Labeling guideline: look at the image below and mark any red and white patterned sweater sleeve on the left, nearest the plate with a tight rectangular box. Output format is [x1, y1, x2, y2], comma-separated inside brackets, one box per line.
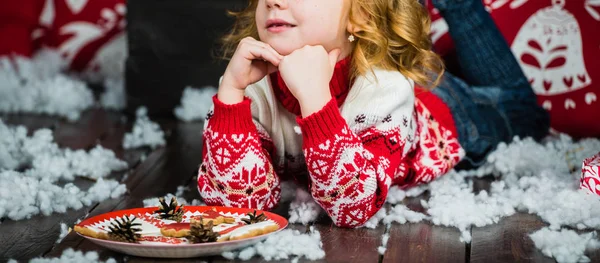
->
[198, 96, 281, 210]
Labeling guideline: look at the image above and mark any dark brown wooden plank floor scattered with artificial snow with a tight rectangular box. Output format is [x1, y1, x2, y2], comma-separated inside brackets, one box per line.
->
[0, 110, 600, 263]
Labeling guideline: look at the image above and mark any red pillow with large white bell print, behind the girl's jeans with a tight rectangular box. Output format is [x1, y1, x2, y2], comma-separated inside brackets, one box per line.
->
[427, 0, 600, 137]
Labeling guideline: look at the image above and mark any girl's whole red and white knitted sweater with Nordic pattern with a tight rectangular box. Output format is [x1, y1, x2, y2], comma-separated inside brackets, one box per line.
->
[198, 59, 464, 227]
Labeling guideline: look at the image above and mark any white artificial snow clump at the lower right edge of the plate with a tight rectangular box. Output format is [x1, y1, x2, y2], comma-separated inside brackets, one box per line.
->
[222, 227, 325, 261]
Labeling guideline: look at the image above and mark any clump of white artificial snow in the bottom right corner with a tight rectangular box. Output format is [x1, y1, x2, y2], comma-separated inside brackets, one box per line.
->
[530, 227, 600, 263]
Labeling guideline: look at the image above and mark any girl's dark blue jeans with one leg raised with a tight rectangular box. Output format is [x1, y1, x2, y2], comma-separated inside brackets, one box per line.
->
[432, 0, 550, 168]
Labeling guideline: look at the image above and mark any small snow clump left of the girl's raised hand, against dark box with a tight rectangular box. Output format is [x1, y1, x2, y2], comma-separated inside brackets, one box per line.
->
[175, 87, 217, 122]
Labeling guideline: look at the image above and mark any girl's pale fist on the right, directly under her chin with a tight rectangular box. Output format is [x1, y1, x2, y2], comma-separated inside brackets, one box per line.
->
[279, 46, 341, 117]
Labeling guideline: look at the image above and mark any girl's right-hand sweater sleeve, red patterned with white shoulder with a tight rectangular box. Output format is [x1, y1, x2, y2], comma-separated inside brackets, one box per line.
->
[298, 72, 416, 227]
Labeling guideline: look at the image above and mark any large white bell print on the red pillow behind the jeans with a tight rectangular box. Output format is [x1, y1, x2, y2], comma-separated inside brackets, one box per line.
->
[511, 0, 592, 99]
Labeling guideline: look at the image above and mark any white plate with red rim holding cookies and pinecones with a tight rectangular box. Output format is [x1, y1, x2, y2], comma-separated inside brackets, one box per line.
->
[76, 206, 288, 258]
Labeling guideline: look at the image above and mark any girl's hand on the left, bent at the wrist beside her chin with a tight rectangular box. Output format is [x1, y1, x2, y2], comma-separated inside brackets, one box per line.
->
[217, 37, 283, 104]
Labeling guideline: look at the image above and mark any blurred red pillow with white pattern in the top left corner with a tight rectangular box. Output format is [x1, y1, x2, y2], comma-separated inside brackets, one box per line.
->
[0, 0, 126, 78]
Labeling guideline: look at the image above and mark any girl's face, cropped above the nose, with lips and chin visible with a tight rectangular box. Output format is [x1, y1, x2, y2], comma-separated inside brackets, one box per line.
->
[256, 0, 352, 59]
